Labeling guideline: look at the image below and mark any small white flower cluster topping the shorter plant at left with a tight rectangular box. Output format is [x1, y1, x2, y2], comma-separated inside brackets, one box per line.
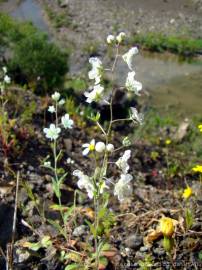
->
[43, 92, 74, 141]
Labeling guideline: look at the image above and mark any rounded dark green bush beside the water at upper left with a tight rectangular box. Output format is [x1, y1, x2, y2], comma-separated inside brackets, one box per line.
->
[0, 13, 68, 94]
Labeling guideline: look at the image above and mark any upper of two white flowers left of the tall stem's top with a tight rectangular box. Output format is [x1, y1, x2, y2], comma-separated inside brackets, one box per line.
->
[88, 57, 103, 84]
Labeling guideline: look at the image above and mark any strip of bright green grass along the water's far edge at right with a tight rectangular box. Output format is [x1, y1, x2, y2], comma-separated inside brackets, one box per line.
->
[131, 33, 202, 56]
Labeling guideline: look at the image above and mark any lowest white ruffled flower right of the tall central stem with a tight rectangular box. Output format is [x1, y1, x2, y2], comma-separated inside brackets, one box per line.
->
[114, 174, 133, 201]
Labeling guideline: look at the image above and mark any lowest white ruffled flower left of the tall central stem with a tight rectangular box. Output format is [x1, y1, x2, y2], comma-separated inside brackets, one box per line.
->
[73, 170, 94, 199]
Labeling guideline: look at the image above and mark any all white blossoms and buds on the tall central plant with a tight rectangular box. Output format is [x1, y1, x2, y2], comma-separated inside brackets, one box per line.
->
[72, 32, 143, 201]
